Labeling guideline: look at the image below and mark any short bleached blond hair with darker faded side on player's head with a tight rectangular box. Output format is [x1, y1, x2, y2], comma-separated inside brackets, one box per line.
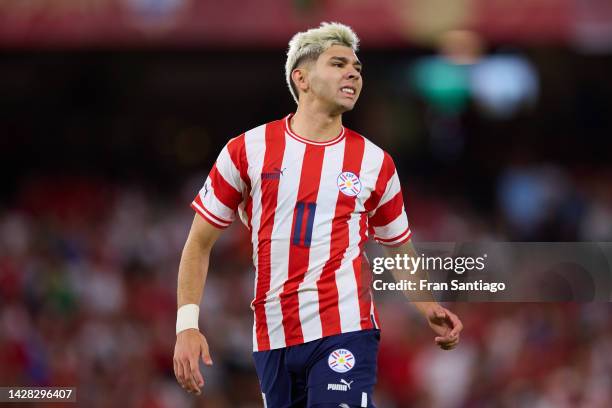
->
[285, 23, 359, 103]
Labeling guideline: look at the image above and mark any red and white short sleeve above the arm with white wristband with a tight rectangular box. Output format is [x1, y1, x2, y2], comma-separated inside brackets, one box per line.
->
[191, 138, 246, 228]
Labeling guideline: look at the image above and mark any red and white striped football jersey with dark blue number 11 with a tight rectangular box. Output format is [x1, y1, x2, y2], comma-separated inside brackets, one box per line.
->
[191, 115, 411, 351]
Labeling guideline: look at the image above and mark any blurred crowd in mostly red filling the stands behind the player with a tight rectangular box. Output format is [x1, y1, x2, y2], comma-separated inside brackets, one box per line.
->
[0, 169, 612, 408]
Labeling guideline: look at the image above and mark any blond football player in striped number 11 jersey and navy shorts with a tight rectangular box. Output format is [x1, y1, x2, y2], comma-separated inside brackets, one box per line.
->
[174, 23, 462, 408]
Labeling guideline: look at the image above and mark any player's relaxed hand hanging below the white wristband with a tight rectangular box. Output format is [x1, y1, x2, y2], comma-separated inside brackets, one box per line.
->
[174, 329, 212, 395]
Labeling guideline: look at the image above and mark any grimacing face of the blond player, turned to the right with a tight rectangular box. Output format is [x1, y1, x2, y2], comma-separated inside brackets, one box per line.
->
[304, 45, 363, 114]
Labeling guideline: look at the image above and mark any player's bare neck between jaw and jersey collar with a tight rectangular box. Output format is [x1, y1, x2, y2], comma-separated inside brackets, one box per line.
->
[291, 105, 342, 142]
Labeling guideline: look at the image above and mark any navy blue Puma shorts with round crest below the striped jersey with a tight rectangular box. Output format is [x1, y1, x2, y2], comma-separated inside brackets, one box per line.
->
[253, 329, 380, 408]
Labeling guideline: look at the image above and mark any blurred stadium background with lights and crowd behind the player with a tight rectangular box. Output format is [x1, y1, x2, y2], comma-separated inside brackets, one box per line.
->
[0, 0, 612, 408]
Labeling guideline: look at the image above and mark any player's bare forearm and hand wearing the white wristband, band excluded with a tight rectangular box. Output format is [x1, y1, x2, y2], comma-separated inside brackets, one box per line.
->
[174, 214, 222, 395]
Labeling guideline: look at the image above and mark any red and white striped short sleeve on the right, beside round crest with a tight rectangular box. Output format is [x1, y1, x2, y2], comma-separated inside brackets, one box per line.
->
[368, 153, 412, 246]
